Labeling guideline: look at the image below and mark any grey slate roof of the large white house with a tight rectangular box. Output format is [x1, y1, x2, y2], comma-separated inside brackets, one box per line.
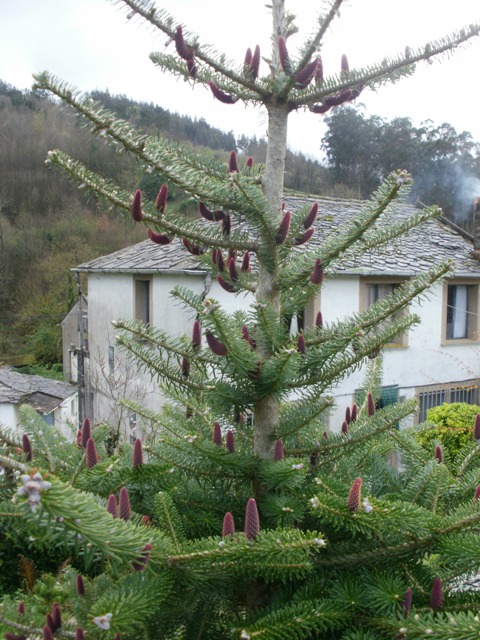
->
[76, 196, 480, 277]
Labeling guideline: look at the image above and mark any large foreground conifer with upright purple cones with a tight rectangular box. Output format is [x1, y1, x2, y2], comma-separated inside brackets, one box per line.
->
[0, 0, 480, 640]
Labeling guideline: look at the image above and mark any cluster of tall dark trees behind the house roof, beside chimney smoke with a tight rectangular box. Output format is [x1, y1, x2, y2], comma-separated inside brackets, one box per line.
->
[322, 106, 480, 224]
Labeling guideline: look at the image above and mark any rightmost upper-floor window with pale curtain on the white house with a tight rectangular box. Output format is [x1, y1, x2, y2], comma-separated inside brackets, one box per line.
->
[444, 282, 478, 340]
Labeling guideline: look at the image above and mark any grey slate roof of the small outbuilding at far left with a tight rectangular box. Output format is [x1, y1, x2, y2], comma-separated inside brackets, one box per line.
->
[0, 367, 77, 413]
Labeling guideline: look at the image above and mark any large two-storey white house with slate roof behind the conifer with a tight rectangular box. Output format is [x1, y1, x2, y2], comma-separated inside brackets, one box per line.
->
[69, 197, 480, 432]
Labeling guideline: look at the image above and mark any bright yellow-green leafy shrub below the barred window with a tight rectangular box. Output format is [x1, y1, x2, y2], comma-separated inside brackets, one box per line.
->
[417, 402, 480, 457]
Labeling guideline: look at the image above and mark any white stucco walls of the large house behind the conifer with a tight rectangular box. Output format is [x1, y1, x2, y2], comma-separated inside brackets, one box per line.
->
[89, 273, 480, 435]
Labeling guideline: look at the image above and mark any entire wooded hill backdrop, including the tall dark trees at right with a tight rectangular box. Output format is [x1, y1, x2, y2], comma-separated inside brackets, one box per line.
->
[0, 80, 480, 367]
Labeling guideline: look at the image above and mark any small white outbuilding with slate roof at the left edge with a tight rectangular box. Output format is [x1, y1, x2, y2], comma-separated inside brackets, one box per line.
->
[0, 367, 78, 439]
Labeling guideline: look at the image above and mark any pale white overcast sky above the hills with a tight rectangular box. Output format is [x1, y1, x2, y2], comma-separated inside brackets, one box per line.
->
[0, 0, 480, 156]
